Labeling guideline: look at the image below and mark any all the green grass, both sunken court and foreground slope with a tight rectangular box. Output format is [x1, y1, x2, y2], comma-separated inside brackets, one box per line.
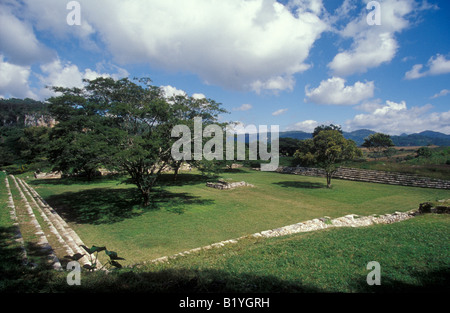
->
[0, 170, 450, 293]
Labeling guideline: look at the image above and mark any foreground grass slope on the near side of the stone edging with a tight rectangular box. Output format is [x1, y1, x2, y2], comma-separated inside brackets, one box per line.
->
[6, 214, 450, 293]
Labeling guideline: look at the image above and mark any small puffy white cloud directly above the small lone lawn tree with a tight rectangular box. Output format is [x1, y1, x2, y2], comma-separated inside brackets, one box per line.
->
[305, 77, 375, 105]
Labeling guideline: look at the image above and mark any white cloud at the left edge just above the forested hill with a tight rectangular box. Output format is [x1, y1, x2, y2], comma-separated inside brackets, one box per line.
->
[0, 54, 37, 99]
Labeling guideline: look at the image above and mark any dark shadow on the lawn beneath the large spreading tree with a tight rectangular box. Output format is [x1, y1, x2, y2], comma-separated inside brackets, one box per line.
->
[45, 188, 214, 225]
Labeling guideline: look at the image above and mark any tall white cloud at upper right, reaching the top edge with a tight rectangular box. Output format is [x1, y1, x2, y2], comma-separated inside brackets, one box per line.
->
[328, 0, 420, 76]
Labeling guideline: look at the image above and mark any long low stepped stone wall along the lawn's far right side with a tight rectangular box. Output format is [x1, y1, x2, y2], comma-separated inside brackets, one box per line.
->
[277, 167, 450, 189]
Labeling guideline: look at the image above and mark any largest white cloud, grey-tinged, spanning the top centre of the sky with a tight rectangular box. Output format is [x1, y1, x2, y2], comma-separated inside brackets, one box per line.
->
[19, 0, 328, 92]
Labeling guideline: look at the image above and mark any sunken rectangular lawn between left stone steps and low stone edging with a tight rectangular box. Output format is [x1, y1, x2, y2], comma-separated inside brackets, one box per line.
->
[25, 170, 450, 265]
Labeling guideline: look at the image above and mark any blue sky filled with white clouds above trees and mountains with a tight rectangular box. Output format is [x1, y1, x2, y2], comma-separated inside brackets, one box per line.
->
[0, 0, 450, 135]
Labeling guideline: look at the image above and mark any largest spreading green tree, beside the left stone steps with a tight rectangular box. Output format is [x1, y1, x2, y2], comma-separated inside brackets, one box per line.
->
[49, 78, 227, 205]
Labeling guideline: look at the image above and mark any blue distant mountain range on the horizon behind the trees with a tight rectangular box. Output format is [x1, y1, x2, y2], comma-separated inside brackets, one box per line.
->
[280, 129, 450, 147]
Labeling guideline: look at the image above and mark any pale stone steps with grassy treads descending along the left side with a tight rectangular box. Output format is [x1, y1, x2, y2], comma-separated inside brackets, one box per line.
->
[5, 175, 101, 270]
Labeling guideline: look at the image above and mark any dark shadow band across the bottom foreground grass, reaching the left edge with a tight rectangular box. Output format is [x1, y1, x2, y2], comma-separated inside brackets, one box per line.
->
[0, 227, 450, 294]
